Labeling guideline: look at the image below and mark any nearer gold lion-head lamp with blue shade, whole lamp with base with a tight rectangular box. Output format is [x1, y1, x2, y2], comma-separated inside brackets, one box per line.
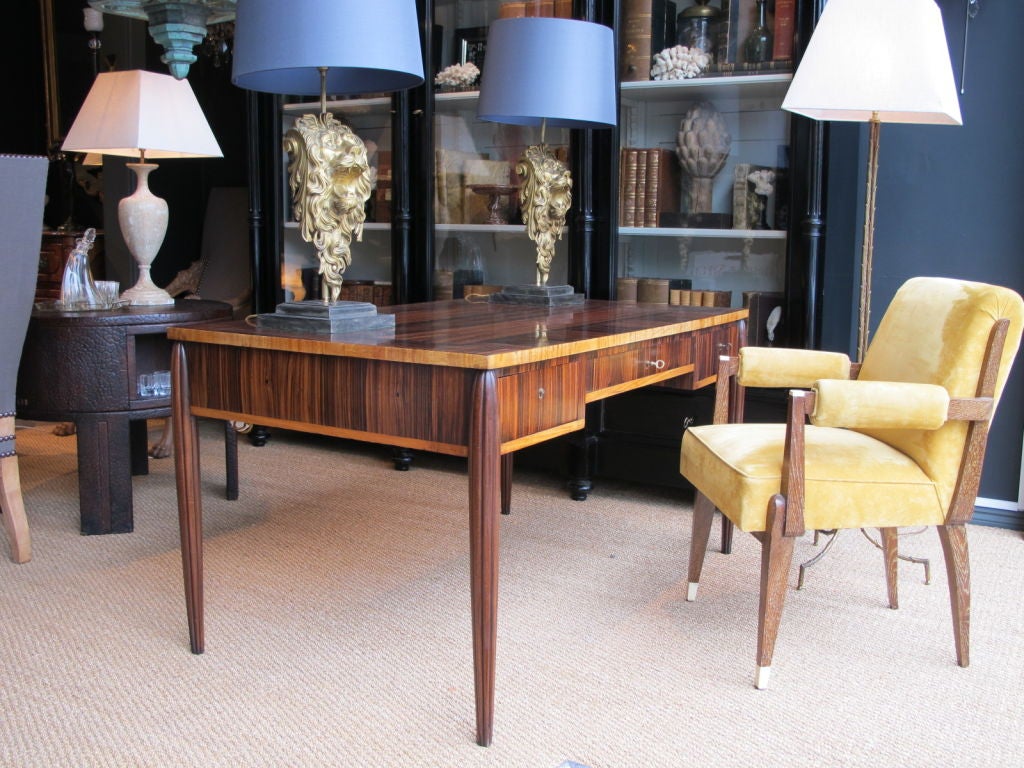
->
[231, 0, 423, 334]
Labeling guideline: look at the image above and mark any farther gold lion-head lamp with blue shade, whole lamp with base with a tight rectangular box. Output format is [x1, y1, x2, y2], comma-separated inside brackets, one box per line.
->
[477, 16, 616, 306]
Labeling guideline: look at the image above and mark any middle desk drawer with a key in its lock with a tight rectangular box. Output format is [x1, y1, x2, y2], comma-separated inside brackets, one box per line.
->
[587, 336, 693, 399]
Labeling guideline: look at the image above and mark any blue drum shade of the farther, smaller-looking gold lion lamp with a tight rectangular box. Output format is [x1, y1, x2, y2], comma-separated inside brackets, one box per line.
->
[476, 16, 617, 128]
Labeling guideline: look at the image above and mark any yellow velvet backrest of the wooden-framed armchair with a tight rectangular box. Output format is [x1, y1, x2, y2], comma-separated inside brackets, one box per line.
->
[858, 278, 1024, 509]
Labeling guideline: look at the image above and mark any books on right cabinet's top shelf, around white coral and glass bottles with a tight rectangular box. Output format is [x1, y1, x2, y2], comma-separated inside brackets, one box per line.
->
[620, 0, 797, 81]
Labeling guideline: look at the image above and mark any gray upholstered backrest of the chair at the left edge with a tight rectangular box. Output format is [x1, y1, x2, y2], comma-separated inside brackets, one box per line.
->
[0, 155, 49, 415]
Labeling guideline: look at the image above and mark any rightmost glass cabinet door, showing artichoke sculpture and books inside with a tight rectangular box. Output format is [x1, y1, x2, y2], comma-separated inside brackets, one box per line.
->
[613, 0, 805, 348]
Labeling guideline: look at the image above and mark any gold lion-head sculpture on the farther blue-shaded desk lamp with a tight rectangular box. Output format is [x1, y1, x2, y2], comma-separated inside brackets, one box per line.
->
[515, 143, 572, 286]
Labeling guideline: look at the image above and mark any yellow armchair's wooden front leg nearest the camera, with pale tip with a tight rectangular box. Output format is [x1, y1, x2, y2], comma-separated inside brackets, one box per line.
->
[754, 494, 794, 689]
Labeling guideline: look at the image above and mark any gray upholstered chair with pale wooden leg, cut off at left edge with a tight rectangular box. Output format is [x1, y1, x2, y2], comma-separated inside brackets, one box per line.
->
[0, 155, 49, 562]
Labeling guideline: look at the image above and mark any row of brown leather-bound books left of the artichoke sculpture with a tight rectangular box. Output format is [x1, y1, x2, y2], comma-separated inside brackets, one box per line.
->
[618, 146, 682, 226]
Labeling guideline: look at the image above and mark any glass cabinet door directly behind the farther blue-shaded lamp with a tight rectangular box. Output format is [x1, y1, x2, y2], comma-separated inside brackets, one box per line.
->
[433, 0, 571, 299]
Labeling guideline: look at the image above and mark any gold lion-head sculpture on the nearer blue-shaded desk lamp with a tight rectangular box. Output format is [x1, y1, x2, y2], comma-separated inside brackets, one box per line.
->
[285, 113, 372, 303]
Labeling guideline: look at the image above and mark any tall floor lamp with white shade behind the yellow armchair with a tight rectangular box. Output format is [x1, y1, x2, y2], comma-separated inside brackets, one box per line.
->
[782, 0, 963, 360]
